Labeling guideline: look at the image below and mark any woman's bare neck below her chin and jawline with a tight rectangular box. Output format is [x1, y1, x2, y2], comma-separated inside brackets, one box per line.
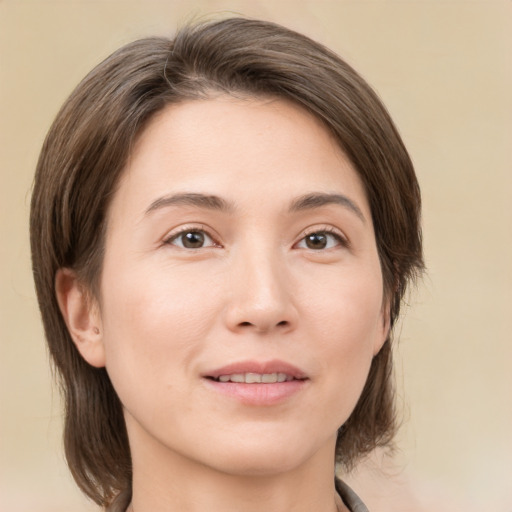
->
[128, 424, 347, 512]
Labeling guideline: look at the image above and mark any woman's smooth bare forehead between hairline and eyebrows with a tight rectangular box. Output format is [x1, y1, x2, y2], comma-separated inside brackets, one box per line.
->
[112, 95, 367, 222]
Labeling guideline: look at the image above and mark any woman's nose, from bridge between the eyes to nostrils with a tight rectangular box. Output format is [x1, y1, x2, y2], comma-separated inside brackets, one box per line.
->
[222, 245, 298, 334]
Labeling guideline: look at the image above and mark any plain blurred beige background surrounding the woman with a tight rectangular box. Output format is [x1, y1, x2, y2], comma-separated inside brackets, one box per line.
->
[0, 0, 512, 512]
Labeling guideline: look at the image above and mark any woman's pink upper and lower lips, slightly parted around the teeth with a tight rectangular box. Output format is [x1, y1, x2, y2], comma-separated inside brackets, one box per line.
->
[201, 360, 309, 407]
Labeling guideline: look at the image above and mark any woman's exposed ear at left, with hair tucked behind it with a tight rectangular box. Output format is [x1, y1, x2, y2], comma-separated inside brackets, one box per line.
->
[55, 268, 105, 368]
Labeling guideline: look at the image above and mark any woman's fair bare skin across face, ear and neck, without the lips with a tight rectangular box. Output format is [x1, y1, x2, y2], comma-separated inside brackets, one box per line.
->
[57, 95, 388, 512]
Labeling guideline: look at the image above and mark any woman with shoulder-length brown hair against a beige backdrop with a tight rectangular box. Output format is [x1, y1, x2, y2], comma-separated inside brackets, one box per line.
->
[31, 18, 422, 512]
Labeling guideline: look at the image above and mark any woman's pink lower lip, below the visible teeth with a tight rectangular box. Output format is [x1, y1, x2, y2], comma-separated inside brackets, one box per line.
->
[205, 379, 307, 405]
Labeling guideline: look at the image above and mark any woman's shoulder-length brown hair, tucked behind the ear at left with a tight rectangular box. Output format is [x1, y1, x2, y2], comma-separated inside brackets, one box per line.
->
[30, 18, 423, 505]
